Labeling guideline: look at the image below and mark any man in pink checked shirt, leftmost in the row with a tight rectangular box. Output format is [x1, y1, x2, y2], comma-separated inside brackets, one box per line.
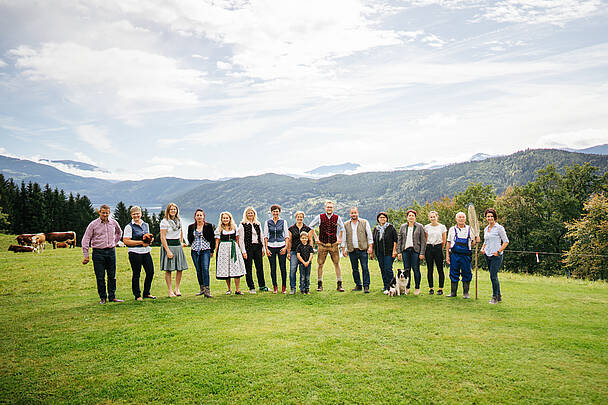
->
[82, 204, 123, 304]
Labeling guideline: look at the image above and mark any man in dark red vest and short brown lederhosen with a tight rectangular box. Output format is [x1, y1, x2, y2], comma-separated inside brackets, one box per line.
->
[308, 201, 344, 292]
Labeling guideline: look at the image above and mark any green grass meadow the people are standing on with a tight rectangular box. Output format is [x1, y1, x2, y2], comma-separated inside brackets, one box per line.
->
[0, 236, 608, 404]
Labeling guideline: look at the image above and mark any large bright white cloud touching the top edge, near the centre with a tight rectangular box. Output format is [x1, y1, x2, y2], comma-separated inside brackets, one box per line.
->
[111, 0, 402, 79]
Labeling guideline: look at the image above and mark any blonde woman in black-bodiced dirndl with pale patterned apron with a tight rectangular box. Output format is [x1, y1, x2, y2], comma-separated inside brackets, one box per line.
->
[215, 212, 245, 295]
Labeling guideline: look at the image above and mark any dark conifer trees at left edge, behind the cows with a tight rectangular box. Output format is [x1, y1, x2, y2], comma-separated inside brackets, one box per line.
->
[0, 174, 97, 243]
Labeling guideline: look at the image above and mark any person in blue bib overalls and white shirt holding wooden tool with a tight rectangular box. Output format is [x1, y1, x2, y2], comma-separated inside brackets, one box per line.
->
[446, 212, 479, 298]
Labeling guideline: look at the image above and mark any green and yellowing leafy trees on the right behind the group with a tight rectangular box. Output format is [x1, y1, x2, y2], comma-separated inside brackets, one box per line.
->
[388, 163, 608, 280]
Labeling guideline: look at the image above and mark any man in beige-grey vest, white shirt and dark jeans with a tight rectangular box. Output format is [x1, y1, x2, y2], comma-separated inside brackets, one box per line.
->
[342, 207, 374, 294]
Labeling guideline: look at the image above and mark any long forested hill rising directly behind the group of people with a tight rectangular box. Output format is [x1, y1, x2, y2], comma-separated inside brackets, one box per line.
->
[177, 149, 608, 222]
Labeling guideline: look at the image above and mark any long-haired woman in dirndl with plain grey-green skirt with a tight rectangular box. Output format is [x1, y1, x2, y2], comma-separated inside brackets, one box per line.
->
[160, 203, 188, 297]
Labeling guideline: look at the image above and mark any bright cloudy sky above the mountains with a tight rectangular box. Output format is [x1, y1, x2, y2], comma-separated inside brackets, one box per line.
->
[0, 0, 608, 179]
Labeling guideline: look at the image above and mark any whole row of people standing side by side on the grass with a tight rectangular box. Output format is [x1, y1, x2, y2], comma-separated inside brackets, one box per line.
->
[82, 201, 509, 304]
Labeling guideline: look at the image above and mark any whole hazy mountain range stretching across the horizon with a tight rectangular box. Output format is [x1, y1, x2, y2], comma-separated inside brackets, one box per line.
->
[0, 145, 608, 222]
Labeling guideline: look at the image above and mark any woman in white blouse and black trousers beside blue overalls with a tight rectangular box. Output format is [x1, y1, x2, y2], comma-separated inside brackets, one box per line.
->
[424, 211, 448, 295]
